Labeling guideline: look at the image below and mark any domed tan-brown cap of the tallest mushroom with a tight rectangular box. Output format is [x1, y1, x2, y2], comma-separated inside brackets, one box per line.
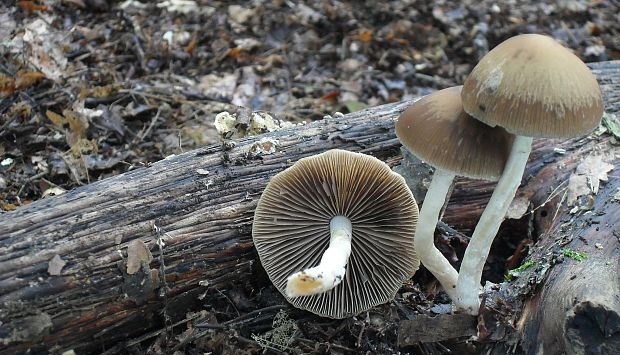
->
[461, 34, 603, 138]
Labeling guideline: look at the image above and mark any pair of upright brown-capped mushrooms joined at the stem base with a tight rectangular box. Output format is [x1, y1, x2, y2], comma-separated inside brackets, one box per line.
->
[396, 34, 603, 314]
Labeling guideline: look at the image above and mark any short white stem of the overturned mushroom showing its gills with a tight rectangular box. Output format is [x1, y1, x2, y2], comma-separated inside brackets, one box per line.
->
[286, 216, 353, 297]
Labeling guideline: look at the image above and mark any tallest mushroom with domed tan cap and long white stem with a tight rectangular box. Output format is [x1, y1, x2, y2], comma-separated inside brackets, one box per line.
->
[457, 34, 603, 314]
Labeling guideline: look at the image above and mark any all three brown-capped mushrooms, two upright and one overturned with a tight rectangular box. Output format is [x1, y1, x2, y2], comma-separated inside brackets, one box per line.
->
[252, 34, 603, 318]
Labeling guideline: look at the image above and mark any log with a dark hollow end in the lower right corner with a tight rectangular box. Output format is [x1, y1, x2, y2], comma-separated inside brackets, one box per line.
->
[508, 144, 620, 354]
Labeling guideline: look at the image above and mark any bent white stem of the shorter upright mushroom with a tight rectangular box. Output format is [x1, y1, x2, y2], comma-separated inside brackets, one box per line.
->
[413, 169, 458, 300]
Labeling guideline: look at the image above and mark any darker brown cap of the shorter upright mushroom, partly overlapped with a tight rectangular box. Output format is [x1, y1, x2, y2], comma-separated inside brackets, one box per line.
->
[396, 86, 513, 181]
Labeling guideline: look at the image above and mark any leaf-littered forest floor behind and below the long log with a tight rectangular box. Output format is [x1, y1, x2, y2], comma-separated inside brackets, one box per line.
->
[0, 0, 620, 353]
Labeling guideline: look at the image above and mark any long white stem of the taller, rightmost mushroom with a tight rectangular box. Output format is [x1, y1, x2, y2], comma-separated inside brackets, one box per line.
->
[455, 136, 532, 315]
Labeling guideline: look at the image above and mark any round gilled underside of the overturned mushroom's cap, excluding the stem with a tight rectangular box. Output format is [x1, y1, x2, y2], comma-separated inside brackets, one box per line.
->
[252, 150, 419, 318]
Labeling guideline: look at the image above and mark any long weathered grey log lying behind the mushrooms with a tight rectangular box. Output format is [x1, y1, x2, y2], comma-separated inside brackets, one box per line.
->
[0, 62, 620, 354]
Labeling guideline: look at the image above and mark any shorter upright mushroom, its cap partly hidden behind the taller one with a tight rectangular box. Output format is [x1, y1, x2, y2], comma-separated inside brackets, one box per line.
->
[396, 86, 512, 301]
